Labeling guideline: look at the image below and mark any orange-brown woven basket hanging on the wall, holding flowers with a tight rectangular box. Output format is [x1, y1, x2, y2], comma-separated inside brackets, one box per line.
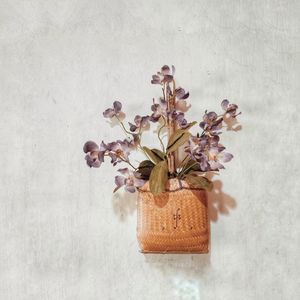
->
[137, 179, 209, 253]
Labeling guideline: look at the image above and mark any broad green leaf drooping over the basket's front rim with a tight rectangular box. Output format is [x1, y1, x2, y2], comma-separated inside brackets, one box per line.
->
[149, 161, 168, 195]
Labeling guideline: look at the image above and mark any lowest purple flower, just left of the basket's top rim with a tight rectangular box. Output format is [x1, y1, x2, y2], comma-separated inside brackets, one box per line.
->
[114, 168, 145, 193]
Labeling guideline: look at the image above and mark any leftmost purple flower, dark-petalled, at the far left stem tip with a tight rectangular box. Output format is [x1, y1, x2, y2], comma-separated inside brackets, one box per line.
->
[83, 141, 107, 168]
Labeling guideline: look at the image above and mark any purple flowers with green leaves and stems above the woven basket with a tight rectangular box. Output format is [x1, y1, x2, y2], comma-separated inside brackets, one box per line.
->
[83, 65, 240, 195]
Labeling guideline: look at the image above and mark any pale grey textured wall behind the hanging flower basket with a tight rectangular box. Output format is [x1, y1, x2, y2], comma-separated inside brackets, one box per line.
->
[0, 0, 300, 300]
